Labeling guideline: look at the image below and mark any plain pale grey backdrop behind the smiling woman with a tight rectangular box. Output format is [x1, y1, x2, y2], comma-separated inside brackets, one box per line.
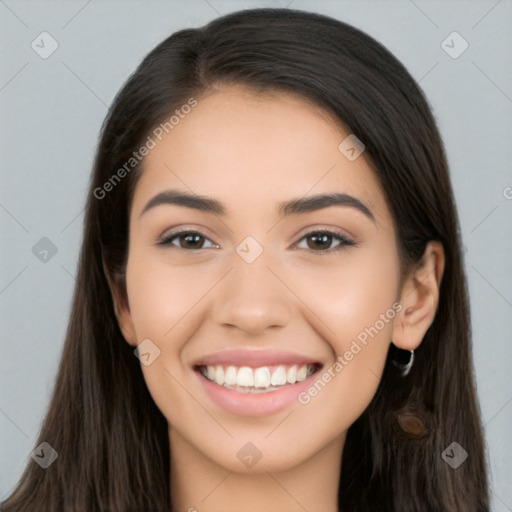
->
[0, 0, 512, 512]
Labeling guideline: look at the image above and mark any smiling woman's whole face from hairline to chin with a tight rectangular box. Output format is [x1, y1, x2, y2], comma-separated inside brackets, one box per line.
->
[118, 86, 401, 472]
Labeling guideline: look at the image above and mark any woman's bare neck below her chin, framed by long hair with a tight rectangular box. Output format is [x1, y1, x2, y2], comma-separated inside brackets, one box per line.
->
[169, 427, 345, 512]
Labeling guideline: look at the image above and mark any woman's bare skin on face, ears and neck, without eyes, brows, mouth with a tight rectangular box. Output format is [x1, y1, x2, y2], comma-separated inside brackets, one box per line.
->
[112, 86, 444, 512]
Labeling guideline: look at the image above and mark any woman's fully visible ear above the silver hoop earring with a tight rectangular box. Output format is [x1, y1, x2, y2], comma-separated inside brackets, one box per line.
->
[391, 241, 445, 350]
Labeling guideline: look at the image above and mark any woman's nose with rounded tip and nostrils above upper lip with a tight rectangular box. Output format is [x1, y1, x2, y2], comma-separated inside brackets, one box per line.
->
[213, 255, 293, 335]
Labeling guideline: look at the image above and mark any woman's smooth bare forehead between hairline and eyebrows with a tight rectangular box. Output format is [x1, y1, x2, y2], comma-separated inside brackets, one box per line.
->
[133, 86, 388, 224]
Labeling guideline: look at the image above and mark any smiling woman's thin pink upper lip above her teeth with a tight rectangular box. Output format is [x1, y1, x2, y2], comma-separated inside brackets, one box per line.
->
[194, 349, 320, 368]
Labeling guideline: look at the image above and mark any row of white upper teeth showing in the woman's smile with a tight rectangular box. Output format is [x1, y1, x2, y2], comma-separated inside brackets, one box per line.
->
[201, 364, 315, 392]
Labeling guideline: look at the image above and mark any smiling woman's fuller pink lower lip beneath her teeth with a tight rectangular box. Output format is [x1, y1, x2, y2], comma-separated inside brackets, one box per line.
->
[195, 371, 319, 417]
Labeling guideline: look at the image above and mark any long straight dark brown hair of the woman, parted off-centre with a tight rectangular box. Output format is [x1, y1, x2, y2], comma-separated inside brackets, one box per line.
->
[3, 9, 489, 512]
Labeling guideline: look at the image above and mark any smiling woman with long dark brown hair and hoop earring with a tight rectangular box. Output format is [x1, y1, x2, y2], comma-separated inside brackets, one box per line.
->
[3, 9, 489, 512]
